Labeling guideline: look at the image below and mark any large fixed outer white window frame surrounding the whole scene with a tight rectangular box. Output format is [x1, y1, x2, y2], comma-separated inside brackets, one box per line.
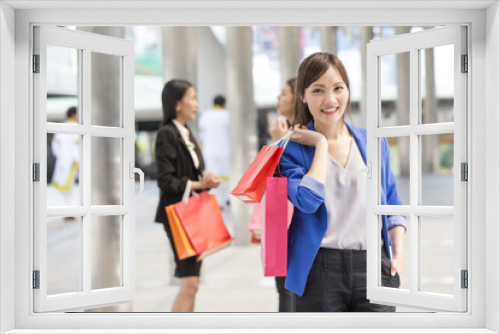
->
[0, 1, 500, 333]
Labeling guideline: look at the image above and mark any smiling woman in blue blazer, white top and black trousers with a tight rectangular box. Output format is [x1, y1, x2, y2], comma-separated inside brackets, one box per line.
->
[280, 52, 406, 312]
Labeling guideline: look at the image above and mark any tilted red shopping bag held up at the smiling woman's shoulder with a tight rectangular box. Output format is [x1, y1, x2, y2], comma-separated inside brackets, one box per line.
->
[231, 145, 283, 203]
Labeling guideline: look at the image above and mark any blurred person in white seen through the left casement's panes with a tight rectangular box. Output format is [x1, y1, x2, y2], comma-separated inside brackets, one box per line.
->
[50, 107, 80, 214]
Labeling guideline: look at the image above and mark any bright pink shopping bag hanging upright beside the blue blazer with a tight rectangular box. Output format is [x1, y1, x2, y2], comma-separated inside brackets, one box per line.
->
[261, 176, 289, 276]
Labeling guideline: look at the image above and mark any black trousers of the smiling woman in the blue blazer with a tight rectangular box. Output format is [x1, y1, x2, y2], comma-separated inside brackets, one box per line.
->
[291, 248, 400, 312]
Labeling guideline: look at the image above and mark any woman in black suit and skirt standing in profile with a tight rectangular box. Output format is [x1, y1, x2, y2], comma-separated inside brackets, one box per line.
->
[155, 80, 220, 312]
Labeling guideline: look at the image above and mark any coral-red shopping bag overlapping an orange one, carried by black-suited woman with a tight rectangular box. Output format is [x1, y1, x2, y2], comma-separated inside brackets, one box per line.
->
[174, 191, 233, 261]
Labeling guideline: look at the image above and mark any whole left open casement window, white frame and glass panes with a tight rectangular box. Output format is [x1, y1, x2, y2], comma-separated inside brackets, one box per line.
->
[33, 26, 142, 312]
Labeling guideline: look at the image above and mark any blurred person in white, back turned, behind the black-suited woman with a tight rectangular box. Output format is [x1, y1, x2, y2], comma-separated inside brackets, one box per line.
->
[198, 95, 231, 209]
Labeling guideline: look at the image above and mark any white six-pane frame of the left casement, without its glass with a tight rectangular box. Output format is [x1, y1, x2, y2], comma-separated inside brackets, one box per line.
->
[33, 26, 135, 312]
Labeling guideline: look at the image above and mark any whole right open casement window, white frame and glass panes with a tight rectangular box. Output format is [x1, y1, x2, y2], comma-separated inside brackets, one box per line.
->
[367, 26, 468, 312]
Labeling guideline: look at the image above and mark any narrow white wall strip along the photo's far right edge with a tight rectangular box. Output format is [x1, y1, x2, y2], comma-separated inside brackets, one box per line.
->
[485, 3, 500, 333]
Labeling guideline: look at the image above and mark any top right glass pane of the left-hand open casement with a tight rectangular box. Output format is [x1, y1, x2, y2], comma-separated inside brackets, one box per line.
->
[92, 52, 122, 127]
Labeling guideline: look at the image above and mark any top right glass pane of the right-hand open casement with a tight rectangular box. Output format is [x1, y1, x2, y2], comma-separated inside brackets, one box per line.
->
[419, 45, 455, 124]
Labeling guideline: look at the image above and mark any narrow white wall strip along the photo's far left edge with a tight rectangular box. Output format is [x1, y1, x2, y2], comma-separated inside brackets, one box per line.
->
[0, 3, 15, 333]
